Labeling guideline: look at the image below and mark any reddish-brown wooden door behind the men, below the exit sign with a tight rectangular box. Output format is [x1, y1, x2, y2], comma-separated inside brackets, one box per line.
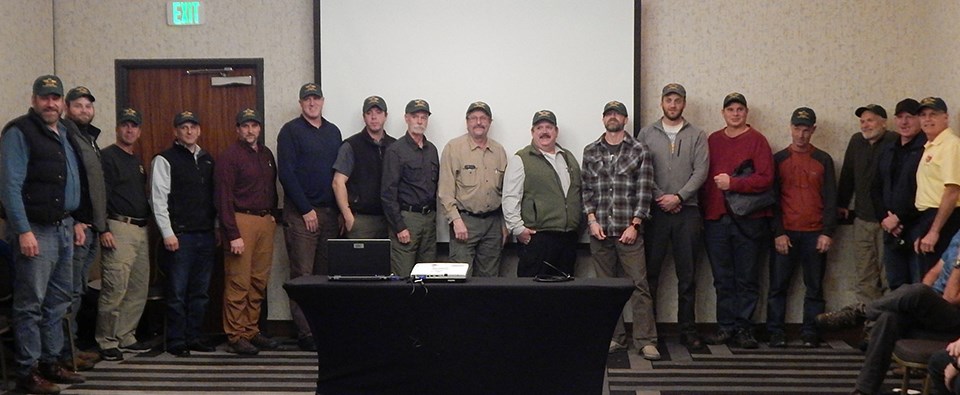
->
[117, 59, 266, 333]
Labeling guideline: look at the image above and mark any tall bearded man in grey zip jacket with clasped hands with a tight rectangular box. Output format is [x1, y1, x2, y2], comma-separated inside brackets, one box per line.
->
[637, 83, 710, 350]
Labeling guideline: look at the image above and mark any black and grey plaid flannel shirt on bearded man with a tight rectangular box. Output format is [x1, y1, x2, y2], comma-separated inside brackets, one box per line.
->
[581, 134, 654, 236]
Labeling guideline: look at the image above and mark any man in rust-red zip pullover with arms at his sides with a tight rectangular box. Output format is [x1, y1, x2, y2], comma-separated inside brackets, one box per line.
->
[767, 107, 837, 348]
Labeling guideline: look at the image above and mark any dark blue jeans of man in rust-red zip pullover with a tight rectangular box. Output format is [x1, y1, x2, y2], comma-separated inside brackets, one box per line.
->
[767, 231, 827, 337]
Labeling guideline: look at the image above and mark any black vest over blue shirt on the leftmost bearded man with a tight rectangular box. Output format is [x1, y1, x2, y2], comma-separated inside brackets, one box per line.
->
[3, 108, 79, 224]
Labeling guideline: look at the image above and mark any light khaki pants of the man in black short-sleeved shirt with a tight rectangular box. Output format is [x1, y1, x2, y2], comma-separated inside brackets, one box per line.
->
[94, 220, 150, 350]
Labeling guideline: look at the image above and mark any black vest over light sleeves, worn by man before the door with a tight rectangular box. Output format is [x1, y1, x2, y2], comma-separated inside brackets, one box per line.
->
[158, 144, 217, 233]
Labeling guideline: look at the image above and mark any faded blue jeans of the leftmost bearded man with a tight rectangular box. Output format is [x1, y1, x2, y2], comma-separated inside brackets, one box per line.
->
[7, 218, 73, 377]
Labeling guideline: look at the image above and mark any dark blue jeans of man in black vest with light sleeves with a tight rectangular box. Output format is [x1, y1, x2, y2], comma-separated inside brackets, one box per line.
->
[163, 231, 216, 348]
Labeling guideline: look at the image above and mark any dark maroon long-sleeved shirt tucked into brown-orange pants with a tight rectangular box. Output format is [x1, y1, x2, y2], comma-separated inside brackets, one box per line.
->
[213, 141, 277, 241]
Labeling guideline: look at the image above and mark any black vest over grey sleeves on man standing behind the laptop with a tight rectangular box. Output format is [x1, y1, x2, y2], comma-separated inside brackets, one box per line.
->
[344, 129, 397, 215]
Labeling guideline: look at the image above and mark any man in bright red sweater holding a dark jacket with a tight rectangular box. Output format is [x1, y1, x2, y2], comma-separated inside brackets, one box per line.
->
[700, 92, 773, 348]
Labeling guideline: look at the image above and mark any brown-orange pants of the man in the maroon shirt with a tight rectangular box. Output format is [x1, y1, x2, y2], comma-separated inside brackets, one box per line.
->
[223, 213, 277, 342]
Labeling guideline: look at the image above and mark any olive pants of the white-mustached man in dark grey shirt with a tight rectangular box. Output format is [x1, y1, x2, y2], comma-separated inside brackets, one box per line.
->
[390, 211, 437, 277]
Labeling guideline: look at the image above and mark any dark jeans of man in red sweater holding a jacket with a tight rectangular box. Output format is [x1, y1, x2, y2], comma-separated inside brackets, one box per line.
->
[703, 215, 767, 331]
